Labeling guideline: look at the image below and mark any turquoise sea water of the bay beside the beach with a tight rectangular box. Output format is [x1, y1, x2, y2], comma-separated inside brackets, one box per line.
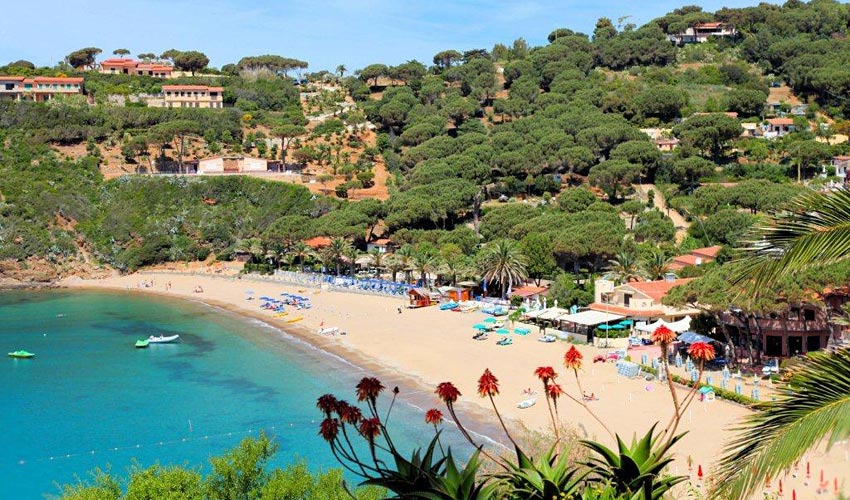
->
[0, 291, 468, 500]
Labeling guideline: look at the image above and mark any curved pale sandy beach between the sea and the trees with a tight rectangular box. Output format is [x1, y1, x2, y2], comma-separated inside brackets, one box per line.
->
[61, 272, 850, 494]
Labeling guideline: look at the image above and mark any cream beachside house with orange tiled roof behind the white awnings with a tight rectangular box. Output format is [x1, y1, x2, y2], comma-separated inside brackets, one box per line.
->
[588, 277, 699, 321]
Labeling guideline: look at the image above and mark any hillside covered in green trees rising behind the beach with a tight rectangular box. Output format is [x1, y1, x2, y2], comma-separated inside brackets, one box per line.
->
[0, 0, 850, 304]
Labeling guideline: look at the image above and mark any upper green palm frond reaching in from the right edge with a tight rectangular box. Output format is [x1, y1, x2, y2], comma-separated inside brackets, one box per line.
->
[738, 189, 850, 289]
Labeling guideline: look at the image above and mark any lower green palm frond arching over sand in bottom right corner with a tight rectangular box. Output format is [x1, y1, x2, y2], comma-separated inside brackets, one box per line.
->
[715, 349, 850, 500]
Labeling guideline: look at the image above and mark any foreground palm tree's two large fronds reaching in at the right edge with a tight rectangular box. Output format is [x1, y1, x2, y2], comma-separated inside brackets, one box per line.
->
[715, 190, 850, 500]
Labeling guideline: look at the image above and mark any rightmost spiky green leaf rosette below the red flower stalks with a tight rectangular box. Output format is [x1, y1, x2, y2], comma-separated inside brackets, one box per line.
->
[581, 424, 687, 500]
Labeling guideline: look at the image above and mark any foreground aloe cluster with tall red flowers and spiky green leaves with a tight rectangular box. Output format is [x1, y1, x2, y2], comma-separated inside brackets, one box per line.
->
[317, 340, 714, 500]
